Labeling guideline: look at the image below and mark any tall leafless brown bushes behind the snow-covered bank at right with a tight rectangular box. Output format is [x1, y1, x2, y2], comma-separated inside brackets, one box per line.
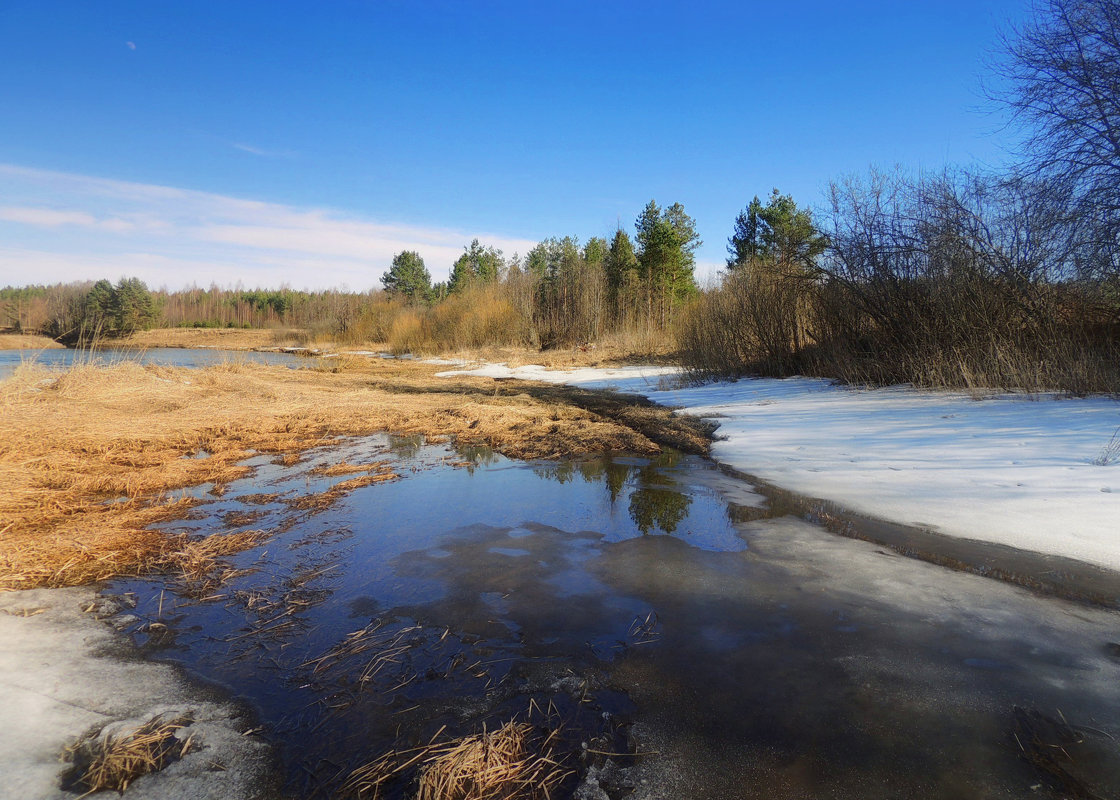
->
[680, 173, 1120, 392]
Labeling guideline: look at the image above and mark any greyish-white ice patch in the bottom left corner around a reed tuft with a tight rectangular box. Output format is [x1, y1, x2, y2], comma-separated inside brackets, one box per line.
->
[0, 587, 276, 800]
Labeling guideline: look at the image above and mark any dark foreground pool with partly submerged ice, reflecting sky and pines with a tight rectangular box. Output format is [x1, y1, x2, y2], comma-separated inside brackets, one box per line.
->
[110, 437, 1120, 799]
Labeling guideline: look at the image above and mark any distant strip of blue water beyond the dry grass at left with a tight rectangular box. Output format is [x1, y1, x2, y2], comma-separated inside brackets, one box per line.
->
[0, 347, 308, 380]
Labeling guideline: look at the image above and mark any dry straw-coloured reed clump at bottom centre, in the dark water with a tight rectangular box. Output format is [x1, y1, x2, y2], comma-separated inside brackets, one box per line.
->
[342, 720, 572, 800]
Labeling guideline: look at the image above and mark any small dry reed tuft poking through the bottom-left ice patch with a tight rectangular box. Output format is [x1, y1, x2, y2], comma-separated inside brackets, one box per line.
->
[63, 716, 193, 797]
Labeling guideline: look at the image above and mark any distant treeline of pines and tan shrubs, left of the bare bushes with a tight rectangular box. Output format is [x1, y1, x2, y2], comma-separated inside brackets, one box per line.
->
[0, 201, 700, 352]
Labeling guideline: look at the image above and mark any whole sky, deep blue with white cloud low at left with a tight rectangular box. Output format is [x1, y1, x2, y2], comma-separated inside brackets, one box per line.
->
[0, 0, 1028, 289]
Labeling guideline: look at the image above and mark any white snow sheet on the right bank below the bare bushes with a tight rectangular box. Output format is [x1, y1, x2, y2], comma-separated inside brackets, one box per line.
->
[441, 365, 1120, 570]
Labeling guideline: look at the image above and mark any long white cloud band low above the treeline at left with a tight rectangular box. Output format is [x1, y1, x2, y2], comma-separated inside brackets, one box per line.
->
[0, 165, 534, 289]
